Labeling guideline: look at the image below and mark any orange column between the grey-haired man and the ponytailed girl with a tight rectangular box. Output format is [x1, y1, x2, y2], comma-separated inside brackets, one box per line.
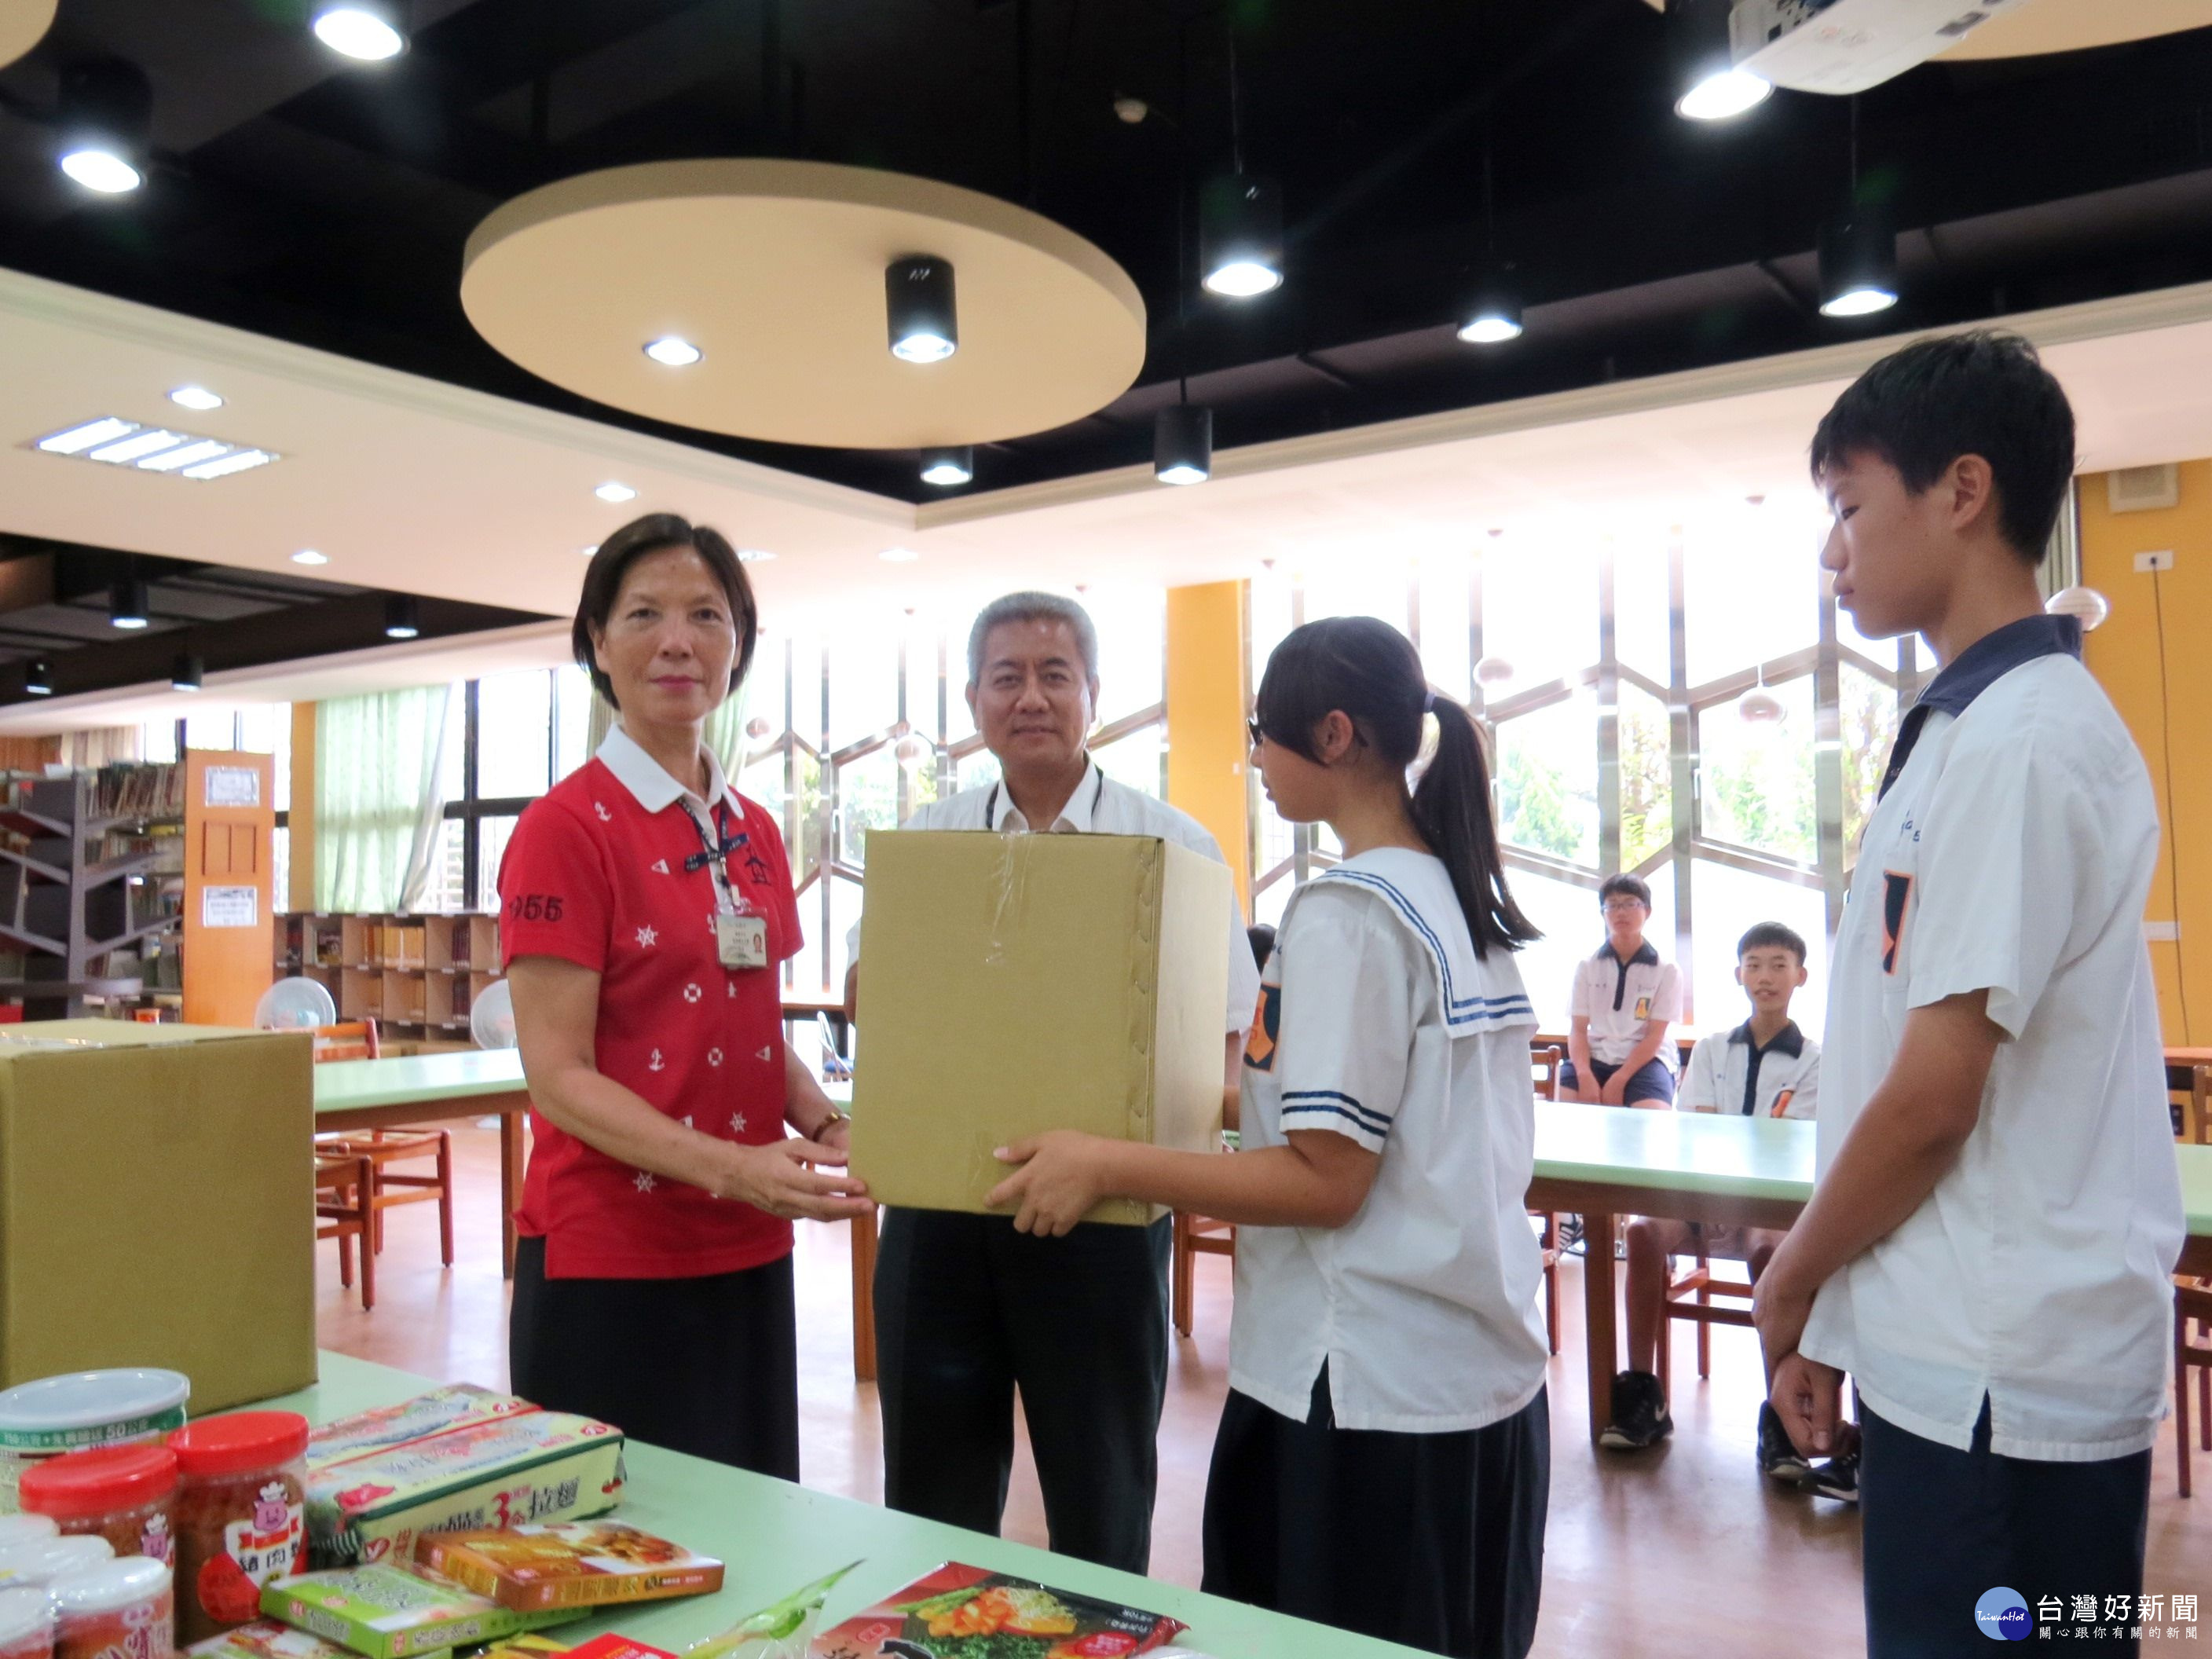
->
[1166, 582, 1252, 916]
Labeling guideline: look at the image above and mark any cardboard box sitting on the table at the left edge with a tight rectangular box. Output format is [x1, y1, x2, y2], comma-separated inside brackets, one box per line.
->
[0, 1020, 314, 1418]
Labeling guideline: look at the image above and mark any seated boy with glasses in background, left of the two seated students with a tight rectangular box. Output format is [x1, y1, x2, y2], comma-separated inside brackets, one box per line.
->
[1559, 876, 1681, 1106]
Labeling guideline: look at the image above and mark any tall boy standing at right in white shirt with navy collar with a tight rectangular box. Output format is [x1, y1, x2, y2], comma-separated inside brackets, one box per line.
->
[1754, 334, 2183, 1659]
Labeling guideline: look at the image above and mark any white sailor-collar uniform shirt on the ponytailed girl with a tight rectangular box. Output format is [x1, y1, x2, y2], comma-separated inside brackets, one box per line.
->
[1230, 848, 1548, 1434]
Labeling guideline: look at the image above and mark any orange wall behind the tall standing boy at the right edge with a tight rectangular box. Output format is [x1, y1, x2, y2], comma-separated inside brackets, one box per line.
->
[2082, 460, 2212, 1044]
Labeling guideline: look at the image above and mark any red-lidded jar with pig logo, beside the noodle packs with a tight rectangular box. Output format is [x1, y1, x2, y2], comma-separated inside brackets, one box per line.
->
[168, 1412, 307, 1646]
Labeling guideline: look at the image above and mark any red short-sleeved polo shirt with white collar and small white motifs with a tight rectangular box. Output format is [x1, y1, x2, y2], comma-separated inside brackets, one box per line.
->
[500, 726, 800, 1279]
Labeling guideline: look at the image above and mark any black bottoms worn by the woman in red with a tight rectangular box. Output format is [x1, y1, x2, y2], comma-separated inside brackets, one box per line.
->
[507, 1239, 799, 1480]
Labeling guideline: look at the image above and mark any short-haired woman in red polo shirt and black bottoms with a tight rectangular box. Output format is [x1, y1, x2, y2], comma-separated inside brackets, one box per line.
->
[500, 513, 867, 1480]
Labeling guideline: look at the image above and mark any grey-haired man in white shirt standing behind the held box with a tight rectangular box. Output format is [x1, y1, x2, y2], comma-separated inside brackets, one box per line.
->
[854, 593, 1258, 1573]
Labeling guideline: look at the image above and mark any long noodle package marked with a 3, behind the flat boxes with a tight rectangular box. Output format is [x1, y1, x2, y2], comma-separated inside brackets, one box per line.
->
[307, 1412, 624, 1566]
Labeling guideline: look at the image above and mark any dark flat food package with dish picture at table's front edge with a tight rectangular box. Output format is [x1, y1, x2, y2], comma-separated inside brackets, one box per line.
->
[808, 1562, 1188, 1659]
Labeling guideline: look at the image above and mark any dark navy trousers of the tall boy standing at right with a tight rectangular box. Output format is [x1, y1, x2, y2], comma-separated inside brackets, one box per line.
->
[1858, 1401, 2150, 1659]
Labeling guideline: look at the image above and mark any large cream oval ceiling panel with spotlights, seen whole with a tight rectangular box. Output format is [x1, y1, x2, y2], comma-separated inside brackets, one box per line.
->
[460, 159, 1144, 449]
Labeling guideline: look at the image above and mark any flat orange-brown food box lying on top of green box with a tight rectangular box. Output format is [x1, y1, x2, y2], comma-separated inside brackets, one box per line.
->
[416, 1520, 721, 1613]
